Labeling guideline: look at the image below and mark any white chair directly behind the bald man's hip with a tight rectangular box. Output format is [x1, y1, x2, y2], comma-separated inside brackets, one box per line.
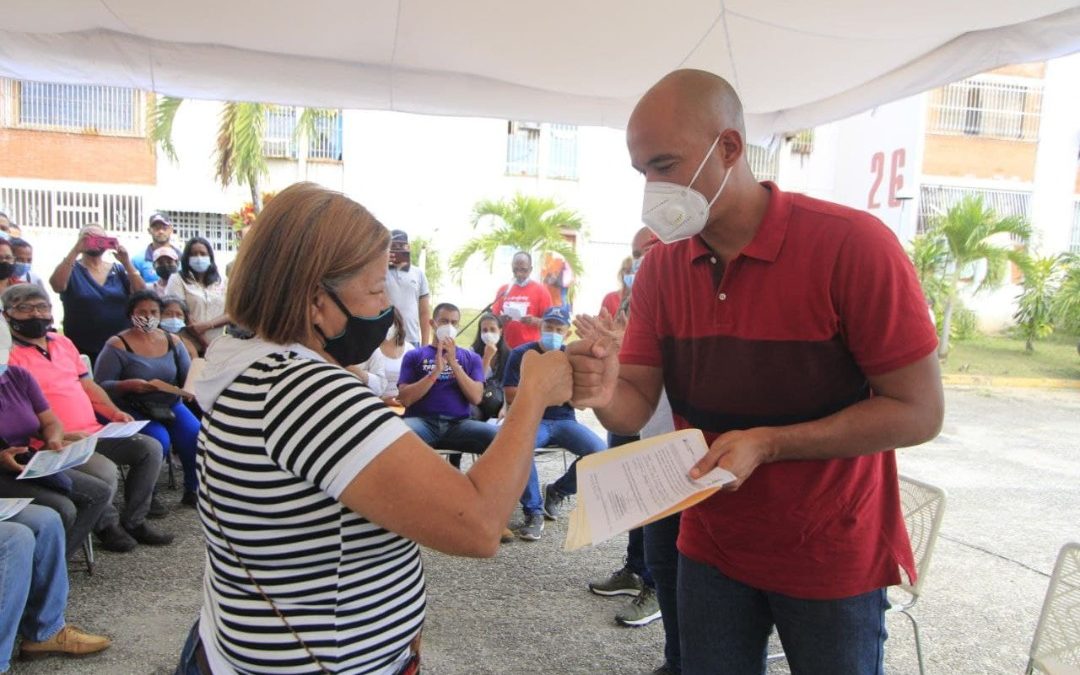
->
[888, 475, 945, 675]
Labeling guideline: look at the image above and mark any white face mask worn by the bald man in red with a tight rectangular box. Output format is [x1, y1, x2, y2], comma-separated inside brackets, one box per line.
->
[642, 136, 734, 244]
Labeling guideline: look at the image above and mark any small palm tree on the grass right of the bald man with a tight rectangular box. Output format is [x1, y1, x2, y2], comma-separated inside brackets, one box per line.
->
[933, 195, 1031, 357]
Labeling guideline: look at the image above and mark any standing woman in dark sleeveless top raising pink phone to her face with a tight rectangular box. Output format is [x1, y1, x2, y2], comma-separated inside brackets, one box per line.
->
[49, 224, 146, 363]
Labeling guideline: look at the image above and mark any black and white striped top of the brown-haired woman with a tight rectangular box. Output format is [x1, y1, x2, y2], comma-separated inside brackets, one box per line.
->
[199, 352, 426, 674]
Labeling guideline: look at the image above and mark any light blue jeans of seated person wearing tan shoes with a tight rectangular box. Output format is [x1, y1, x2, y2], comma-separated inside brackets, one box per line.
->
[0, 504, 68, 672]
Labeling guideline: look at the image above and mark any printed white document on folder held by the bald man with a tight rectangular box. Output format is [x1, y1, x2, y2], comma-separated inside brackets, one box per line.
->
[564, 429, 734, 551]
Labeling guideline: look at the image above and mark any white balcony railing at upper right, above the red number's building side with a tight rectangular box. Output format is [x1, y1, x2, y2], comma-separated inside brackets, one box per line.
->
[928, 76, 1042, 141]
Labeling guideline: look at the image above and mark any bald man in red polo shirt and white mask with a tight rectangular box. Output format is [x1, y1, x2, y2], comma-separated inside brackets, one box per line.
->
[568, 70, 944, 674]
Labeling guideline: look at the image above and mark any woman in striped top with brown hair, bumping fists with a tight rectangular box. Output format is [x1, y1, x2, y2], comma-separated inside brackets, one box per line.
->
[180, 184, 571, 675]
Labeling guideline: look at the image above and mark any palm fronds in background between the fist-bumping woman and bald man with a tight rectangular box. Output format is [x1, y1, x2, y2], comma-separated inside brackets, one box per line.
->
[450, 193, 584, 281]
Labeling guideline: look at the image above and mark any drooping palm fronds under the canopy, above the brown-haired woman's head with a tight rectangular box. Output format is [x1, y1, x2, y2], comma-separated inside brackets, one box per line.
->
[150, 96, 333, 214]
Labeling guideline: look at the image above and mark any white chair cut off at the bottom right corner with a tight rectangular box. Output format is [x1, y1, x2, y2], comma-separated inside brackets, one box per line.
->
[1026, 542, 1080, 675]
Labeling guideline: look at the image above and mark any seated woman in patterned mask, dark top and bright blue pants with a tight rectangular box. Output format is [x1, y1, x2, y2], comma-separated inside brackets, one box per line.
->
[94, 291, 199, 507]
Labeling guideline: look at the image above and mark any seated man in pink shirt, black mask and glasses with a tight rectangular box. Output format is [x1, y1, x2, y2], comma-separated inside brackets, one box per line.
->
[3, 284, 173, 552]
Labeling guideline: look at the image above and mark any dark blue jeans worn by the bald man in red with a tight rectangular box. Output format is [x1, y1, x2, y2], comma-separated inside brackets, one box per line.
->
[678, 552, 889, 675]
